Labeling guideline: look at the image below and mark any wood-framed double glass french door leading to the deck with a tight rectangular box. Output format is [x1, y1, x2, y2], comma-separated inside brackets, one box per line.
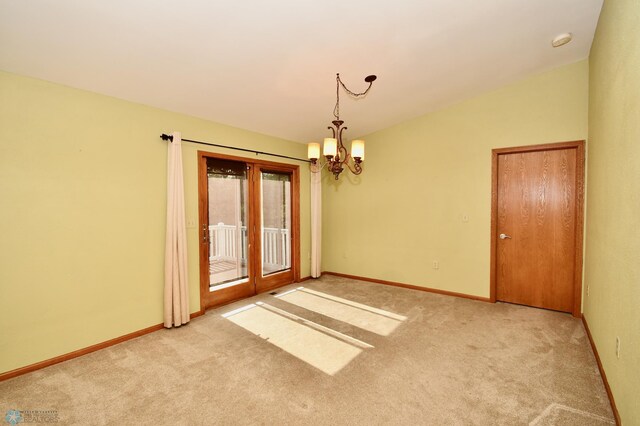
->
[198, 151, 300, 309]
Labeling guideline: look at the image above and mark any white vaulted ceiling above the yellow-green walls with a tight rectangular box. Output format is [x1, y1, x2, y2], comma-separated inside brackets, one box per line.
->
[0, 0, 603, 142]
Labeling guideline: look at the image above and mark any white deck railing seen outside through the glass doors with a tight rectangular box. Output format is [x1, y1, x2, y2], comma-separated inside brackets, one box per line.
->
[209, 223, 291, 270]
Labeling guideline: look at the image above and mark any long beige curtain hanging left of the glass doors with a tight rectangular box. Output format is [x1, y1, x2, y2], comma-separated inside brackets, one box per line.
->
[164, 132, 190, 328]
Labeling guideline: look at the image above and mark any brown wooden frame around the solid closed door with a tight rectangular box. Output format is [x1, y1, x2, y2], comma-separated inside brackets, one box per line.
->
[489, 140, 585, 317]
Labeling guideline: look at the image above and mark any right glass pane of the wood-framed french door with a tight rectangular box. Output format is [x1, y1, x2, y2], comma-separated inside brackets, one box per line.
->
[260, 170, 291, 277]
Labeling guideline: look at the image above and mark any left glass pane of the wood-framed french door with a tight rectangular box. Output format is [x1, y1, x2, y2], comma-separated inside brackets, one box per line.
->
[207, 158, 250, 291]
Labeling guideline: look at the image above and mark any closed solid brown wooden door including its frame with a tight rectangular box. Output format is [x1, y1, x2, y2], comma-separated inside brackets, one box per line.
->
[492, 142, 584, 316]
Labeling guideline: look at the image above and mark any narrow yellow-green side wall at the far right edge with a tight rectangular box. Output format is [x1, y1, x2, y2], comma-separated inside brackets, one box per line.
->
[584, 0, 640, 425]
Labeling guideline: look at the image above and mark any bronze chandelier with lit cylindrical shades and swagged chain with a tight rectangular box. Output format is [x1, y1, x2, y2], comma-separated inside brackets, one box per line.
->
[307, 74, 377, 180]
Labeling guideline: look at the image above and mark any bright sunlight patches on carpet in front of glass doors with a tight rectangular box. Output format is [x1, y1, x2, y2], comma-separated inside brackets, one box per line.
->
[222, 287, 406, 375]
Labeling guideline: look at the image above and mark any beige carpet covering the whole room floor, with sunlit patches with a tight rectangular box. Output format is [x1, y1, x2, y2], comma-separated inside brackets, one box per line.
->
[0, 276, 614, 425]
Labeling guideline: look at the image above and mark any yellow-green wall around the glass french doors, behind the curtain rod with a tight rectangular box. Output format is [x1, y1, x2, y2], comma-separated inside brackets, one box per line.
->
[0, 72, 310, 372]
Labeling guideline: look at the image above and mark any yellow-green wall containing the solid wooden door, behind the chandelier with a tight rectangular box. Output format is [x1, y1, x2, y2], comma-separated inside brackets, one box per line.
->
[322, 61, 588, 297]
